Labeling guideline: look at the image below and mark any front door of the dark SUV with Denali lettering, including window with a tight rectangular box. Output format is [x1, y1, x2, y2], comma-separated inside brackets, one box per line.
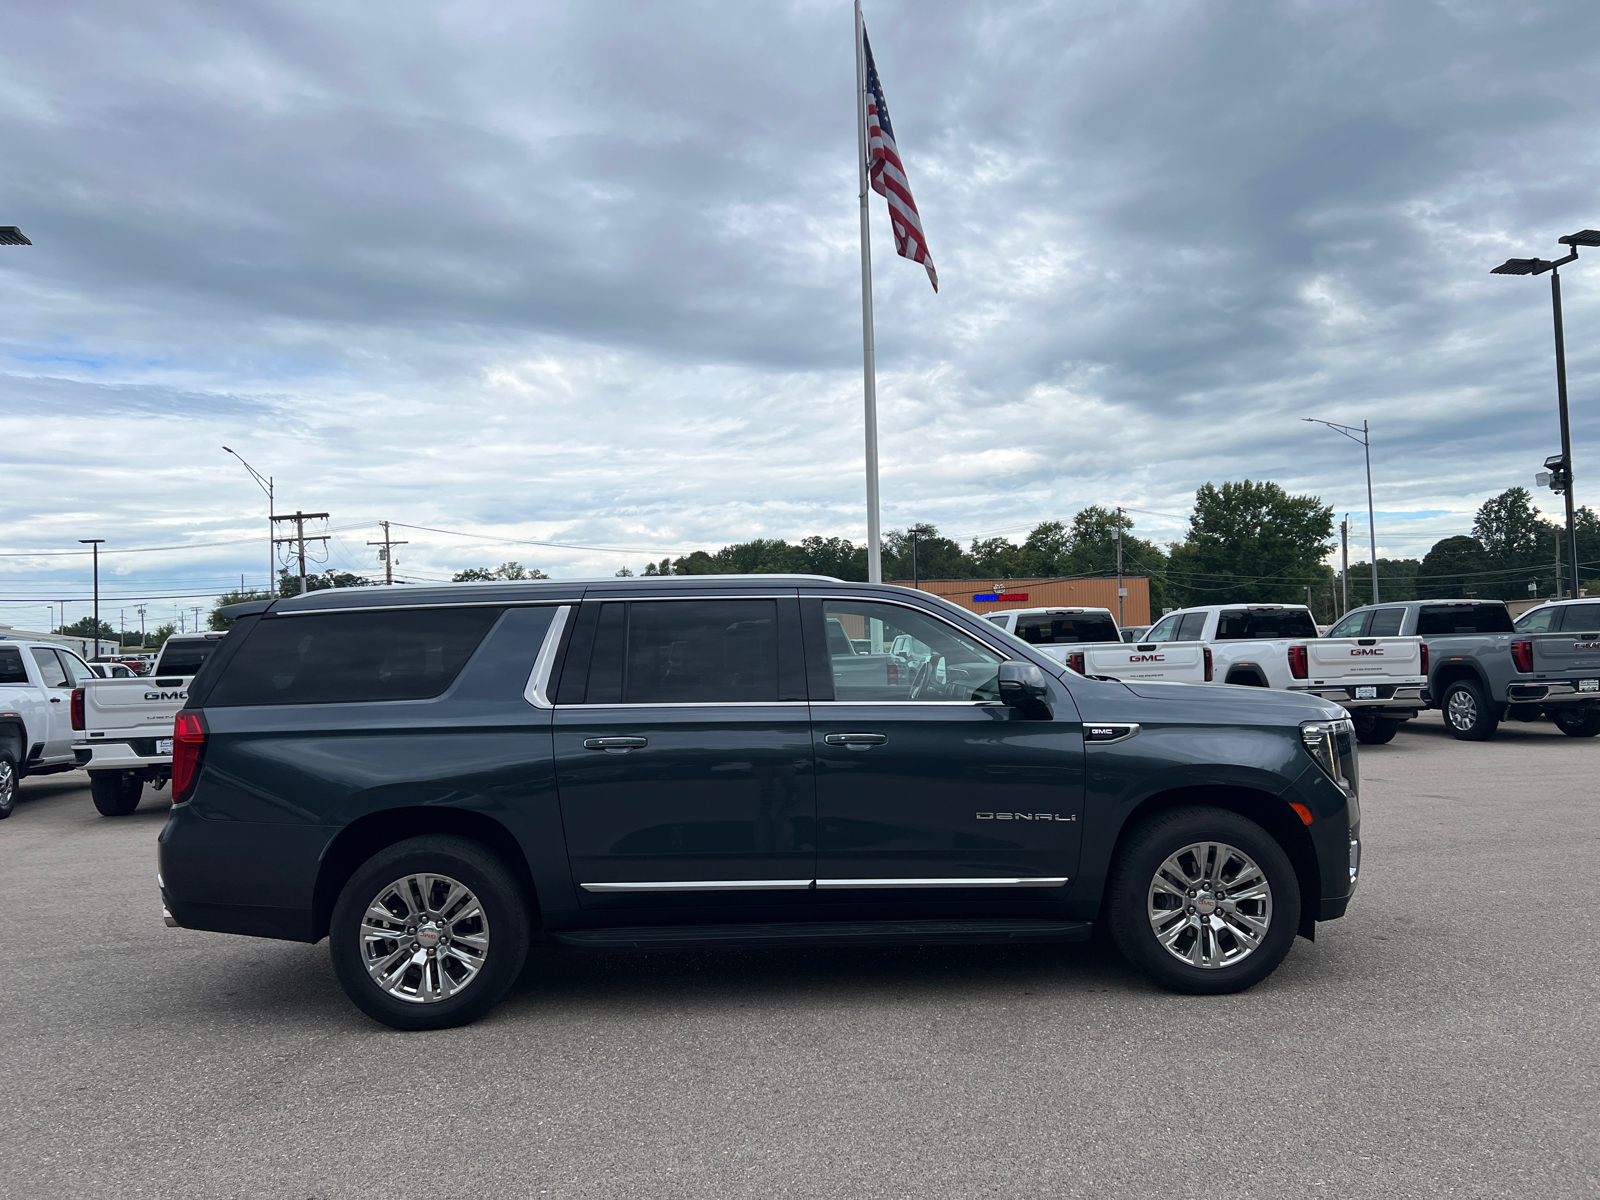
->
[803, 600, 1083, 902]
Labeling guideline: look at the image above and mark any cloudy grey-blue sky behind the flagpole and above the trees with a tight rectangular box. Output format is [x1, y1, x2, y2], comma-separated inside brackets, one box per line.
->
[0, 0, 1600, 626]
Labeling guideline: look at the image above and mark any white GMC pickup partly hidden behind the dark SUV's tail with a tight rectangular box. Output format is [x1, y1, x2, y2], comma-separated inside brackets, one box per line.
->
[72, 634, 226, 816]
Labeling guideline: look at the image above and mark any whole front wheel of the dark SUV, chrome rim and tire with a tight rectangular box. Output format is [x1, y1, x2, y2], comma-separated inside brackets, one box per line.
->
[1106, 808, 1301, 995]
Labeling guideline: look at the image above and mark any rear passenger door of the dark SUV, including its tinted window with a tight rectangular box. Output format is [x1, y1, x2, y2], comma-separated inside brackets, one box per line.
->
[555, 597, 819, 907]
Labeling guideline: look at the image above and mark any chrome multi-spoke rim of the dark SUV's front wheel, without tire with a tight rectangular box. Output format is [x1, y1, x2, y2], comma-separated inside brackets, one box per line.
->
[1149, 842, 1272, 968]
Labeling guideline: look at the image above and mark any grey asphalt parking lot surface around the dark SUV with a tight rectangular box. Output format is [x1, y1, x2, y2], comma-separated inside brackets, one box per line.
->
[0, 715, 1600, 1200]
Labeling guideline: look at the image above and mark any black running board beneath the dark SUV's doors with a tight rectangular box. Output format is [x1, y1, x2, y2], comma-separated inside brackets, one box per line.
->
[549, 920, 1094, 950]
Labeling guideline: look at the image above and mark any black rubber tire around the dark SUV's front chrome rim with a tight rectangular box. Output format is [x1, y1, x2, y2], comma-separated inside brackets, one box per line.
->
[1106, 808, 1301, 995]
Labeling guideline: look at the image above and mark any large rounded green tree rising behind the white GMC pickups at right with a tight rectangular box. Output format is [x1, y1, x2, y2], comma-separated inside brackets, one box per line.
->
[1168, 478, 1333, 605]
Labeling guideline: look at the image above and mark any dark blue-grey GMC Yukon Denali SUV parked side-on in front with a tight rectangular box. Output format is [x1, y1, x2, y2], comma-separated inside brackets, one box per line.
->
[160, 576, 1360, 1029]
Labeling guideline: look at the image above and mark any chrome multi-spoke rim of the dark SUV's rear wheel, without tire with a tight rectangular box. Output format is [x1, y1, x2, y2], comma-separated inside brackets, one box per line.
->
[362, 875, 490, 1005]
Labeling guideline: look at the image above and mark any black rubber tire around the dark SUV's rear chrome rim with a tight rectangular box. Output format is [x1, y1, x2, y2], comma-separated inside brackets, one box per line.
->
[328, 835, 528, 1030]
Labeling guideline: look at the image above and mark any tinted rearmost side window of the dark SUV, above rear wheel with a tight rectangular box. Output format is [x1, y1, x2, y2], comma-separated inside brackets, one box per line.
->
[205, 608, 504, 707]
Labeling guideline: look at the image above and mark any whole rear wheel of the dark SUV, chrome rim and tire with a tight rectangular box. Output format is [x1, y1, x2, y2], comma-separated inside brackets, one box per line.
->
[328, 837, 528, 1030]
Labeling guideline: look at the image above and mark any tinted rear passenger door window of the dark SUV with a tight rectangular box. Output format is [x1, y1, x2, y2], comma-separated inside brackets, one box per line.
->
[582, 600, 780, 704]
